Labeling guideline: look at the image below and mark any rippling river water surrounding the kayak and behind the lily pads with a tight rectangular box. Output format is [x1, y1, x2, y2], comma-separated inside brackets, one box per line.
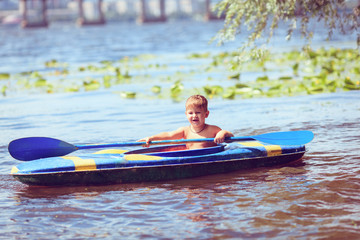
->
[0, 22, 360, 239]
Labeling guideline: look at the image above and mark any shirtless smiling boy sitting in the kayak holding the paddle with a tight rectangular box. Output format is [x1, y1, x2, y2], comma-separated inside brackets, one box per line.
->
[139, 95, 234, 149]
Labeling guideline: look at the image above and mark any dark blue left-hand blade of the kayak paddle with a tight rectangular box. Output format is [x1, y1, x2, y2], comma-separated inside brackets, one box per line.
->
[8, 137, 77, 161]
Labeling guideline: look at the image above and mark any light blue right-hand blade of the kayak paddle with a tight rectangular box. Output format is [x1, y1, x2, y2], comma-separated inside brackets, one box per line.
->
[251, 131, 314, 145]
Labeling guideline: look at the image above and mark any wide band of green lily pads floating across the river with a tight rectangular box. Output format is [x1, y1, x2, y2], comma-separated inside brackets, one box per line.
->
[0, 48, 360, 101]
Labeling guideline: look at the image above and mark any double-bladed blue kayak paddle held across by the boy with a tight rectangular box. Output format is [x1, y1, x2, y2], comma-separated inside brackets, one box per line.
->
[8, 131, 314, 161]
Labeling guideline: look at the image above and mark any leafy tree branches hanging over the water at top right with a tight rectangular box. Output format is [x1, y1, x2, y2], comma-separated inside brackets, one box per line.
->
[214, 0, 360, 61]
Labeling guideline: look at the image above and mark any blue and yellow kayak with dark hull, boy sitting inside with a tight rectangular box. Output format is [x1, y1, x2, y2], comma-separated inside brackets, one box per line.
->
[11, 141, 305, 186]
